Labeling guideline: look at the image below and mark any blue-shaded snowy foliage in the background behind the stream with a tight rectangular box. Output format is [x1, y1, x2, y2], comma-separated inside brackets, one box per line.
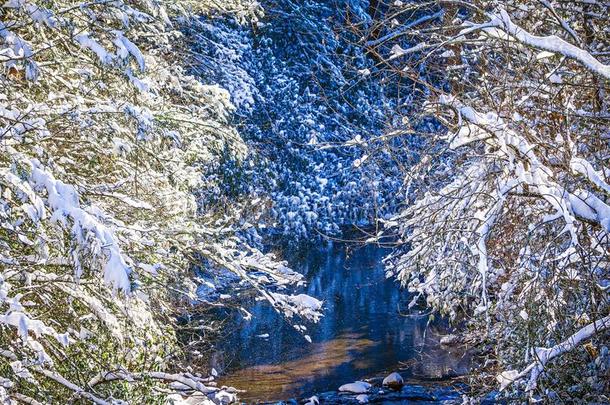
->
[185, 0, 402, 241]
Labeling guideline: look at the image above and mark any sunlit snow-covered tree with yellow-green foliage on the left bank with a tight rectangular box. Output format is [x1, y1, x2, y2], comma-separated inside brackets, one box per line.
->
[0, 0, 319, 404]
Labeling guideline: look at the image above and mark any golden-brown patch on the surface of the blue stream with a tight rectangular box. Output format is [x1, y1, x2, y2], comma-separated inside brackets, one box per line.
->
[219, 333, 376, 401]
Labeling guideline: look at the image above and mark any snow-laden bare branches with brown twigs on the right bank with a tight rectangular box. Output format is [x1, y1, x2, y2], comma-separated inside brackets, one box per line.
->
[376, 0, 610, 400]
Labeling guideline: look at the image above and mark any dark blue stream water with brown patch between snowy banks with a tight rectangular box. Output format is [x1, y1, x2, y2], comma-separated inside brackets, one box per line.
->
[211, 243, 469, 402]
